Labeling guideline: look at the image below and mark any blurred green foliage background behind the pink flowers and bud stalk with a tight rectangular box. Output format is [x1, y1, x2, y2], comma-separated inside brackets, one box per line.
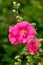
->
[0, 0, 43, 65]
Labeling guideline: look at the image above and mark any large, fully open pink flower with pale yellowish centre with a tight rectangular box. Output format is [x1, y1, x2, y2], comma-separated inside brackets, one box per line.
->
[9, 21, 36, 44]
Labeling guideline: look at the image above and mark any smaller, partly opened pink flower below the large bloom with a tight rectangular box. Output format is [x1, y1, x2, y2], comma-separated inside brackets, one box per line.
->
[27, 38, 40, 54]
